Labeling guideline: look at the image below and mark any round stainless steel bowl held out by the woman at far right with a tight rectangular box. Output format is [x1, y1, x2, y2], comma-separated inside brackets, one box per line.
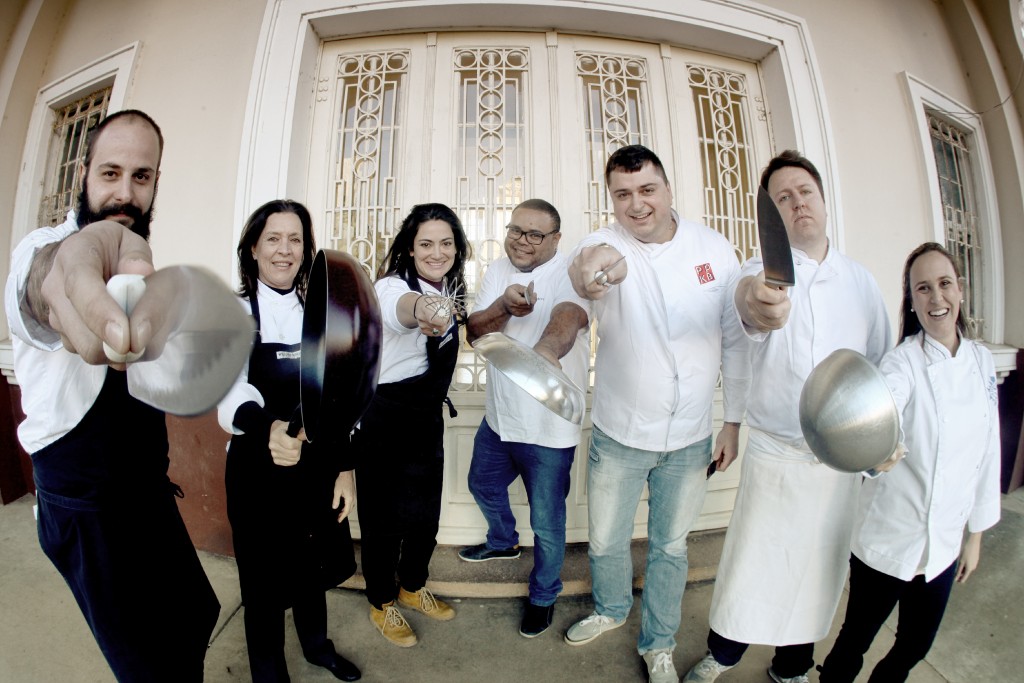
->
[800, 348, 899, 472]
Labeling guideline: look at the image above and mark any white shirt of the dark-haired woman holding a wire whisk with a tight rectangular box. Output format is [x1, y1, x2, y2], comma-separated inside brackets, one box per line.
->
[374, 275, 460, 384]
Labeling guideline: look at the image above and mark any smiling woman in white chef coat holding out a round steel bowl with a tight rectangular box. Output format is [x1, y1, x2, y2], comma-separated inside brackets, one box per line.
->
[820, 242, 999, 683]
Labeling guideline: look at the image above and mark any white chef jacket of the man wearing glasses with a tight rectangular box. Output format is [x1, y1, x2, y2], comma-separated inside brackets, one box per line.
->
[475, 252, 590, 449]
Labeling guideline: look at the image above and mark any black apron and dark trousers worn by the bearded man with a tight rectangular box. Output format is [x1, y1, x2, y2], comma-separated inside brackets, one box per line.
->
[32, 370, 220, 682]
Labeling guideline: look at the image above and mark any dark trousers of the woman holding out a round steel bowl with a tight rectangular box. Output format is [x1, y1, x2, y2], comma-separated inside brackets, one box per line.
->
[819, 555, 956, 683]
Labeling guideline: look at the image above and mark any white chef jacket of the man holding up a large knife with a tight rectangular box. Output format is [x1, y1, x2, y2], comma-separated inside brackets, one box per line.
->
[730, 247, 892, 453]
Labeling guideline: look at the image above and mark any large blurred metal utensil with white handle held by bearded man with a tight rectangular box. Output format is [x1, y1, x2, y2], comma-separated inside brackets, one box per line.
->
[104, 265, 255, 416]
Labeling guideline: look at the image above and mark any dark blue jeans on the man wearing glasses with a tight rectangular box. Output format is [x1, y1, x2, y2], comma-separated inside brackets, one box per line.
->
[469, 419, 575, 606]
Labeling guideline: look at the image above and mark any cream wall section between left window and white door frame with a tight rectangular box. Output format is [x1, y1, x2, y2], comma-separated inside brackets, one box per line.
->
[28, 0, 270, 281]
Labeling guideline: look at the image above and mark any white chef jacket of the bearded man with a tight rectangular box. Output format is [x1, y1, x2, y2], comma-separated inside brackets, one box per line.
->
[4, 211, 106, 453]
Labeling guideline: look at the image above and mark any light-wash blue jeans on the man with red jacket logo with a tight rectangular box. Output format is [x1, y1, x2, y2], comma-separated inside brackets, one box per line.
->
[587, 425, 711, 654]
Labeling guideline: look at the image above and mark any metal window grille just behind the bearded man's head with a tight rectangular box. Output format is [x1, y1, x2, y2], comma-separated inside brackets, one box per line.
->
[39, 87, 111, 225]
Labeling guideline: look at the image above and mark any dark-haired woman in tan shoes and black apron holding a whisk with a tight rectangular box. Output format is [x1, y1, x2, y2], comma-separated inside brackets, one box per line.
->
[352, 204, 469, 647]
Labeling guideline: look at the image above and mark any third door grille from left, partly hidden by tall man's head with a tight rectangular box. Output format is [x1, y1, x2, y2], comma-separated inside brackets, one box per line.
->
[575, 52, 651, 231]
